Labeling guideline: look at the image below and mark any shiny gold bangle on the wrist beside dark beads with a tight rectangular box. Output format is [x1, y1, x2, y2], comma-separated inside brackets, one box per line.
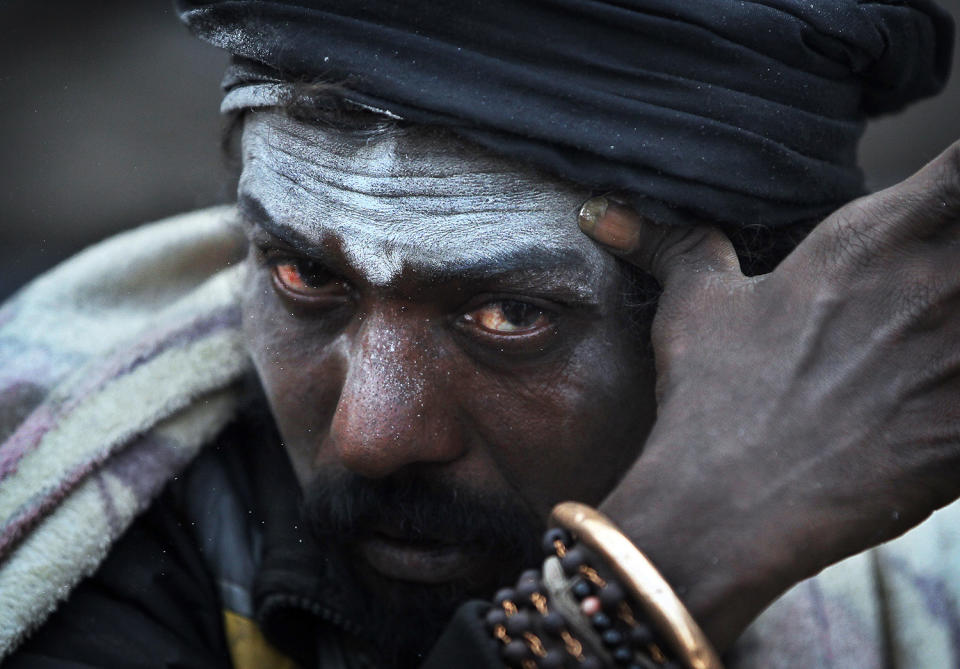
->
[550, 502, 723, 669]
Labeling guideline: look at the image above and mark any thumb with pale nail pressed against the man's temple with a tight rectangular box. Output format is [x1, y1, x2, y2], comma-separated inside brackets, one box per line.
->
[578, 196, 740, 290]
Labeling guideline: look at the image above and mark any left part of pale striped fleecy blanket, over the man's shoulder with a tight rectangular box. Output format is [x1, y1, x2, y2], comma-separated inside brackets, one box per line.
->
[0, 209, 249, 658]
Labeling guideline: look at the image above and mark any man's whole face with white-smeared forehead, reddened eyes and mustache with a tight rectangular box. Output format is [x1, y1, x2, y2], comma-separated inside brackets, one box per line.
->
[240, 111, 653, 594]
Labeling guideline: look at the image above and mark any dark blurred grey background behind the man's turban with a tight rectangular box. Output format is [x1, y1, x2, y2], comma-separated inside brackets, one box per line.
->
[0, 0, 960, 300]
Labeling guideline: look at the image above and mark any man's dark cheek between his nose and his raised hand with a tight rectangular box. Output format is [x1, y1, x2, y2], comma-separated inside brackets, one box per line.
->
[464, 337, 655, 516]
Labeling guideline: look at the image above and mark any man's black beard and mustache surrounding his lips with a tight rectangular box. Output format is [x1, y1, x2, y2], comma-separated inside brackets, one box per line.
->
[302, 470, 543, 667]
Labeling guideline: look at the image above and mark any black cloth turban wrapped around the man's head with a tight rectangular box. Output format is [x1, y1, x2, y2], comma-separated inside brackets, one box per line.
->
[177, 0, 953, 225]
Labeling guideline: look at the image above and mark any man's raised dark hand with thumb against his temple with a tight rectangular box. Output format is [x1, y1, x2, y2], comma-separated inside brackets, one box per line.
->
[581, 143, 960, 648]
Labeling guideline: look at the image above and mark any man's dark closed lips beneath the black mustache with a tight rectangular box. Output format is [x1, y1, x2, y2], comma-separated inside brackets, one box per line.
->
[357, 532, 478, 585]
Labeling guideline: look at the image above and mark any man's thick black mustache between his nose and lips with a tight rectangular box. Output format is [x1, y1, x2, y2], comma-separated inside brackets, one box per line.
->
[301, 470, 544, 564]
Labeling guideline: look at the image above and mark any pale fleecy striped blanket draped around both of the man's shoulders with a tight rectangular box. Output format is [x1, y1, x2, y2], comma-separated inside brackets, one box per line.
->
[0, 208, 960, 669]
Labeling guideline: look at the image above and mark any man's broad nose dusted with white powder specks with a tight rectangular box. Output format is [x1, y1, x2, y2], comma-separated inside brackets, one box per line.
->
[328, 314, 464, 478]
